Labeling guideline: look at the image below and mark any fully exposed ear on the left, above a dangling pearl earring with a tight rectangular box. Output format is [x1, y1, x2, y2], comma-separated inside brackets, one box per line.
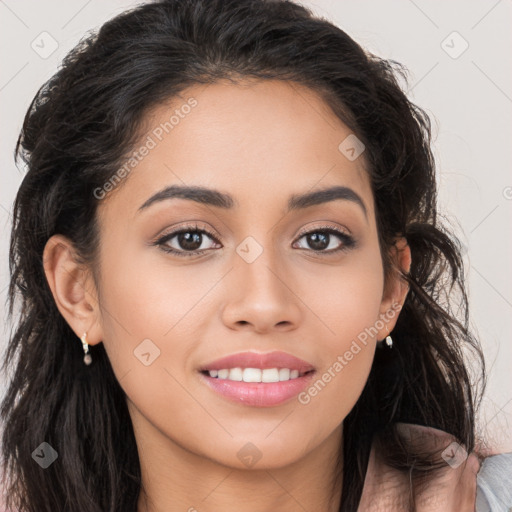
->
[43, 235, 103, 345]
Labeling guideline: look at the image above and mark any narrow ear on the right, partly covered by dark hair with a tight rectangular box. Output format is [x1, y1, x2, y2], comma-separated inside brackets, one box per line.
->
[377, 237, 411, 340]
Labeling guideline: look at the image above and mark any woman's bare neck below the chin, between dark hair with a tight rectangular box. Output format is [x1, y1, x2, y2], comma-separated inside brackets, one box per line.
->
[134, 412, 341, 512]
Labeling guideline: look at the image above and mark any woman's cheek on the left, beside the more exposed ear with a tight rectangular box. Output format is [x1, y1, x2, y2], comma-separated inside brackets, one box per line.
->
[91, 233, 191, 383]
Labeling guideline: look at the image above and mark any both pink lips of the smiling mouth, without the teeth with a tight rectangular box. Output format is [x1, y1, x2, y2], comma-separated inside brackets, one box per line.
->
[200, 352, 316, 407]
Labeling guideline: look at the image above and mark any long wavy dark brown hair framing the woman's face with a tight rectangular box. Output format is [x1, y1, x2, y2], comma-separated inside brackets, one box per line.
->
[0, 0, 485, 512]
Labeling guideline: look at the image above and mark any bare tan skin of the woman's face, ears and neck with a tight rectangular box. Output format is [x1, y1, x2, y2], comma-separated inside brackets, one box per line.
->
[44, 81, 410, 512]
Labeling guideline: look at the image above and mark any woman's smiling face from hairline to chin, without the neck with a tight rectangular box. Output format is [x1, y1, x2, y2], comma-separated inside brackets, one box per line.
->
[79, 81, 404, 468]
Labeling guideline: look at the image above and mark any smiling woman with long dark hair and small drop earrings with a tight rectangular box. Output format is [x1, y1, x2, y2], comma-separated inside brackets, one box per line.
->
[2, 0, 510, 512]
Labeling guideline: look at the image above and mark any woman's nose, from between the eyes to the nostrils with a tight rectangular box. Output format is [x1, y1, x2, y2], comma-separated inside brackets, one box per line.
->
[222, 242, 302, 334]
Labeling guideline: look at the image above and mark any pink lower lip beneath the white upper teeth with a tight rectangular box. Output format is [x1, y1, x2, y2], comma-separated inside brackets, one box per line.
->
[201, 372, 315, 407]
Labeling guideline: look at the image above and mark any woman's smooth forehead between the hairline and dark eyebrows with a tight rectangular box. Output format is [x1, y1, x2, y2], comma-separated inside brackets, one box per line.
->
[98, 80, 373, 216]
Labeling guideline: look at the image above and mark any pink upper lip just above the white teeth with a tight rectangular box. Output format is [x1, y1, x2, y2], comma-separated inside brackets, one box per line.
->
[201, 351, 315, 374]
